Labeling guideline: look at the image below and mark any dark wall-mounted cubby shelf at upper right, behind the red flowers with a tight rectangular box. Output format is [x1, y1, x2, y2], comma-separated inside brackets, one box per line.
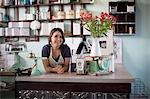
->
[109, 0, 136, 35]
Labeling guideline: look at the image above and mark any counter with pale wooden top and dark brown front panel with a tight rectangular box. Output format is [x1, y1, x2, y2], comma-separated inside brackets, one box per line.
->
[16, 64, 134, 98]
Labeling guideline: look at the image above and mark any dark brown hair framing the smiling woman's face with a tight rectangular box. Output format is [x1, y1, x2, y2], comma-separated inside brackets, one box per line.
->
[48, 28, 65, 44]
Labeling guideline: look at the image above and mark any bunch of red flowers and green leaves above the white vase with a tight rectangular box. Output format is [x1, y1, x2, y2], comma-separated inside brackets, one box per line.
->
[80, 12, 116, 38]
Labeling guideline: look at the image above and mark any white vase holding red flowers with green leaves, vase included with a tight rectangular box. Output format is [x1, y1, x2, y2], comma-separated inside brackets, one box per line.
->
[80, 12, 116, 57]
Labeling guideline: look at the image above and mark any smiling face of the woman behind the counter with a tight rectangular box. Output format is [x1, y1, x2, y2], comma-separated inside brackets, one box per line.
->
[51, 31, 63, 47]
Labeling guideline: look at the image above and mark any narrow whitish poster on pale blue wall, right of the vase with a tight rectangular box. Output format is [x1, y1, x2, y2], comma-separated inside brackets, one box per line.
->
[114, 38, 122, 63]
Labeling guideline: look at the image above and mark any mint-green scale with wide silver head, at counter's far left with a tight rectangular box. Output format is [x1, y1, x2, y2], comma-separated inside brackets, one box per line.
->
[5, 42, 27, 72]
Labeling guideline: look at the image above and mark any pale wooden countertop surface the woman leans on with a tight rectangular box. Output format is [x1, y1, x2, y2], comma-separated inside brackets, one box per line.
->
[16, 64, 134, 83]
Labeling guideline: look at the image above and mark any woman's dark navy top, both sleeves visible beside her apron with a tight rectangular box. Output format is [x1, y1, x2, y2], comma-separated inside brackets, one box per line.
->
[42, 44, 71, 58]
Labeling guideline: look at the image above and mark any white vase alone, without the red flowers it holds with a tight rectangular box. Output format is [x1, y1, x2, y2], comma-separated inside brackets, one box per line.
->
[90, 38, 102, 57]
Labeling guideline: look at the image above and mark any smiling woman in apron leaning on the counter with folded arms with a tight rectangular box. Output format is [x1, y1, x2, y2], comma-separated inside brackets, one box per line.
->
[42, 28, 71, 74]
